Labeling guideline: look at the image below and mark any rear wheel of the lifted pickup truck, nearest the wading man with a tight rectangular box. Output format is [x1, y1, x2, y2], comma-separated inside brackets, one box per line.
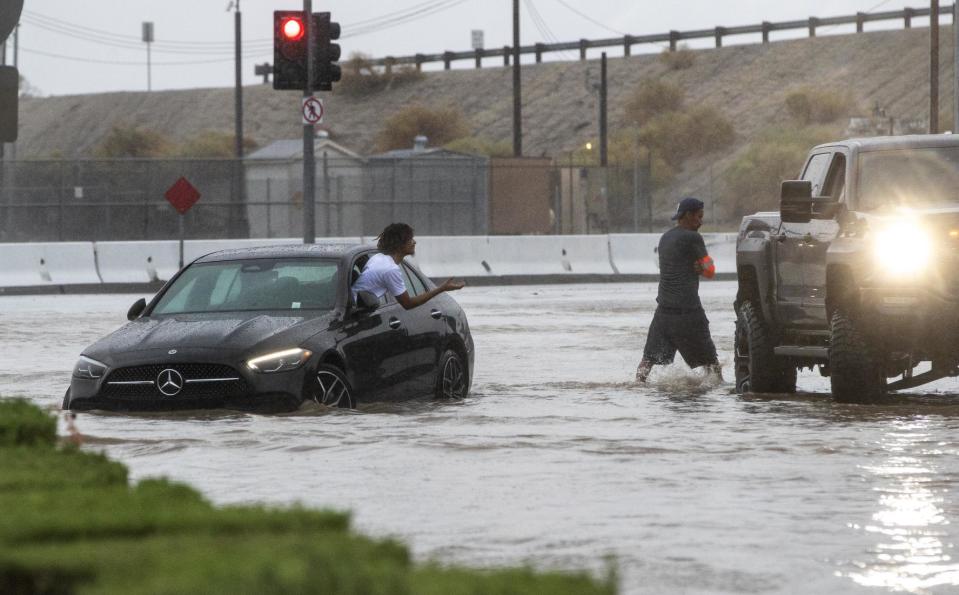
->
[735, 302, 796, 394]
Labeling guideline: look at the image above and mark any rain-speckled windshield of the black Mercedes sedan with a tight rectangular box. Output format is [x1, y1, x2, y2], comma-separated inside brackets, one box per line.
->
[152, 258, 337, 314]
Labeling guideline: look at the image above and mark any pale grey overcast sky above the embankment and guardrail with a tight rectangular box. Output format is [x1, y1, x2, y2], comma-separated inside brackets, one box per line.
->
[0, 0, 951, 95]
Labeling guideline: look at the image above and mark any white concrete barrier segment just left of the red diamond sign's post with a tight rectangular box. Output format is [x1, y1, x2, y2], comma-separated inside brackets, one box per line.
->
[94, 240, 180, 283]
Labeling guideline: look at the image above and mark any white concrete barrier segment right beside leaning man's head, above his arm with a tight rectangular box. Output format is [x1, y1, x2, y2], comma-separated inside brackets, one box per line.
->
[414, 236, 491, 278]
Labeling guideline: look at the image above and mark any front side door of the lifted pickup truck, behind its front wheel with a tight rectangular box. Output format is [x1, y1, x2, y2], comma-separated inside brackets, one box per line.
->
[803, 147, 848, 328]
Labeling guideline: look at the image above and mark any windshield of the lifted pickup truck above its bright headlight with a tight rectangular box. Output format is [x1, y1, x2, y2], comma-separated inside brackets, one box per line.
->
[859, 147, 959, 211]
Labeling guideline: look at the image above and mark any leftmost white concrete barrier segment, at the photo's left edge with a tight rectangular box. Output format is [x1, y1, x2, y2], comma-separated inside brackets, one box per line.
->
[0, 242, 101, 287]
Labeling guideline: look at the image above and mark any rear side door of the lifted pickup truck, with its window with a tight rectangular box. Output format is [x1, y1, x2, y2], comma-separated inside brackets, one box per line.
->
[775, 151, 831, 326]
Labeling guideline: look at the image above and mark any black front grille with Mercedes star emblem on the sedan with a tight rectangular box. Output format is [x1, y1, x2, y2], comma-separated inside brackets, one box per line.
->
[100, 364, 249, 400]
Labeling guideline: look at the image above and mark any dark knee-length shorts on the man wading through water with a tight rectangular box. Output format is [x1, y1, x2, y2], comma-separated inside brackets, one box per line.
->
[643, 306, 719, 368]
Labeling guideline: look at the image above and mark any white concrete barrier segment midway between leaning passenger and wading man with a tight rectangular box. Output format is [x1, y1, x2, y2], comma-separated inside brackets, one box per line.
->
[489, 235, 614, 276]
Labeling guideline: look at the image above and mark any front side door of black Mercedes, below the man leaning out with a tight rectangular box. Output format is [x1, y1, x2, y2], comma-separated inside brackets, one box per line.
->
[337, 254, 410, 400]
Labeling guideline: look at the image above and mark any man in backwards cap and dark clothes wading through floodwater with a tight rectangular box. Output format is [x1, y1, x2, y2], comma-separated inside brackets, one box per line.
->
[636, 198, 723, 382]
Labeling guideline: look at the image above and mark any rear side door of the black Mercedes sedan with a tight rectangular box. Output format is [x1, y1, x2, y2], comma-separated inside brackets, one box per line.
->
[401, 262, 446, 396]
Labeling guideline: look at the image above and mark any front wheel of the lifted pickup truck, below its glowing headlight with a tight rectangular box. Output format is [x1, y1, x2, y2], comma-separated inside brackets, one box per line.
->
[829, 310, 886, 403]
